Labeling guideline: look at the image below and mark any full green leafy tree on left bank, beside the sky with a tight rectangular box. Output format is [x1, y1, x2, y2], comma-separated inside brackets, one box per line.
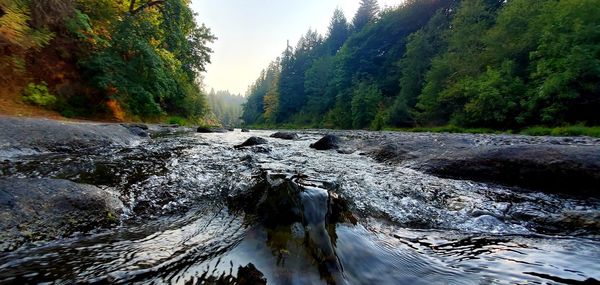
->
[84, 0, 215, 118]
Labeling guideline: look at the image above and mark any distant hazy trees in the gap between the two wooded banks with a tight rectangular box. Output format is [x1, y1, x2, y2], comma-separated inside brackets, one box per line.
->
[208, 89, 246, 127]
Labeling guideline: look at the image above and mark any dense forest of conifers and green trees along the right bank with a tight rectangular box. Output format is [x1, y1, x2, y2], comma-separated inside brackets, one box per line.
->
[243, 0, 600, 129]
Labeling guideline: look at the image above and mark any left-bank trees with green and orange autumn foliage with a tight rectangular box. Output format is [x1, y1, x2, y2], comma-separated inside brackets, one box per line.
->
[0, 0, 215, 119]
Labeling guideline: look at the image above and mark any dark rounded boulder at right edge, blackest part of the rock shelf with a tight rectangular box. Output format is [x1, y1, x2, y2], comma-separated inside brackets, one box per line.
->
[419, 144, 600, 197]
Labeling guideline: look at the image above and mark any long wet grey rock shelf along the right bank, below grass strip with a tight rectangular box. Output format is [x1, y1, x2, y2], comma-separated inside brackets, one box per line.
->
[358, 133, 600, 197]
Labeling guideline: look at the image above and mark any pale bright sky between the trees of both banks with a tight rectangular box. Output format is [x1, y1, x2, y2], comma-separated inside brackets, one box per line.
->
[192, 0, 403, 94]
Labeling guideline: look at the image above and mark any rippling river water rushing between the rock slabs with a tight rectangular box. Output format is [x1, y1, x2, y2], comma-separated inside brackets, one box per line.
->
[0, 131, 600, 284]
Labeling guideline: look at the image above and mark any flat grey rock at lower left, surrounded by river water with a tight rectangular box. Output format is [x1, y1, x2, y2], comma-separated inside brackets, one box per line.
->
[0, 178, 123, 251]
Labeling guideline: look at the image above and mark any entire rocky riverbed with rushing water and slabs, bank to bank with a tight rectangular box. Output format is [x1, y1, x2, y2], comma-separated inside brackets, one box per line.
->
[0, 117, 600, 284]
